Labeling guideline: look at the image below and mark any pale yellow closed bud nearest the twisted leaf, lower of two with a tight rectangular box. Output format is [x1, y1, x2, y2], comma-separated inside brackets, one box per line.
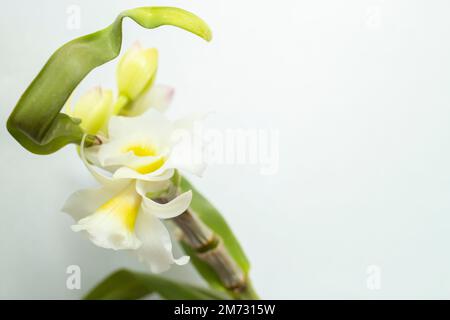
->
[67, 87, 113, 135]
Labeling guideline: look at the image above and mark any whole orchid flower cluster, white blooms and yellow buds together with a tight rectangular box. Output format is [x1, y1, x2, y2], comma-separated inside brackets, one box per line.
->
[63, 45, 204, 272]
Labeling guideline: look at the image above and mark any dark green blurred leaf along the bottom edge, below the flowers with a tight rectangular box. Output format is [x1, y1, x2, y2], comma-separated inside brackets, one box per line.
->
[85, 270, 225, 300]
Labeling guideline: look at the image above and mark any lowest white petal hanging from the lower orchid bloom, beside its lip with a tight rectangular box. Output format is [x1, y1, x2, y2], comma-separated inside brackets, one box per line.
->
[136, 210, 189, 273]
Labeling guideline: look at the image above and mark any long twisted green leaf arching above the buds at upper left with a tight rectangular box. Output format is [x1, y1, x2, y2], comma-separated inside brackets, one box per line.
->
[7, 7, 211, 154]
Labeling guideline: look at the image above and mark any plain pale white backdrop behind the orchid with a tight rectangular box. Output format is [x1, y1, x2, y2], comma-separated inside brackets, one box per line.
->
[0, 0, 450, 299]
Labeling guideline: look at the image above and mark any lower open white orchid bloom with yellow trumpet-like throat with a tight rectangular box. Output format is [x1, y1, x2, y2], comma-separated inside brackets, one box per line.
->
[63, 177, 192, 273]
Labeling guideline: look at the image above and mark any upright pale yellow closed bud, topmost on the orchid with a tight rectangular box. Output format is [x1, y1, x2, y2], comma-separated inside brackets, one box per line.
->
[117, 44, 158, 101]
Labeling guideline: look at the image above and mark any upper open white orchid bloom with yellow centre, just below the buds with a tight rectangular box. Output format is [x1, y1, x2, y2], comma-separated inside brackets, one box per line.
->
[87, 109, 205, 181]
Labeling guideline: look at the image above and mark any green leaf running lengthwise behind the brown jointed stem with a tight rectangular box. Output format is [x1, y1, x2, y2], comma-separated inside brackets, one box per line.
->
[179, 177, 250, 289]
